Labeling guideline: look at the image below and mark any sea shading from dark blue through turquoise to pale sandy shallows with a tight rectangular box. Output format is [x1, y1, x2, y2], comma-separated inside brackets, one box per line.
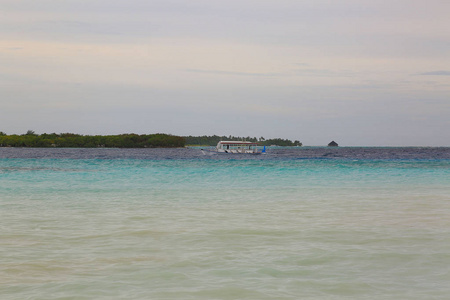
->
[0, 147, 450, 300]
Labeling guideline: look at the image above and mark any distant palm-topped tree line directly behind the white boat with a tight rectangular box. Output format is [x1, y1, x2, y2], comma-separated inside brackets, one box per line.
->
[184, 135, 302, 146]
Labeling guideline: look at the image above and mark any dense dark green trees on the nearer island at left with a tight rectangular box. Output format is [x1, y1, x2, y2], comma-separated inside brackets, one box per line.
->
[0, 130, 185, 148]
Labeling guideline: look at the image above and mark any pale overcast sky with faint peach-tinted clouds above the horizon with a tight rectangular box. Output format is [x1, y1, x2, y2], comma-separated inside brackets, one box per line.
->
[0, 0, 450, 146]
